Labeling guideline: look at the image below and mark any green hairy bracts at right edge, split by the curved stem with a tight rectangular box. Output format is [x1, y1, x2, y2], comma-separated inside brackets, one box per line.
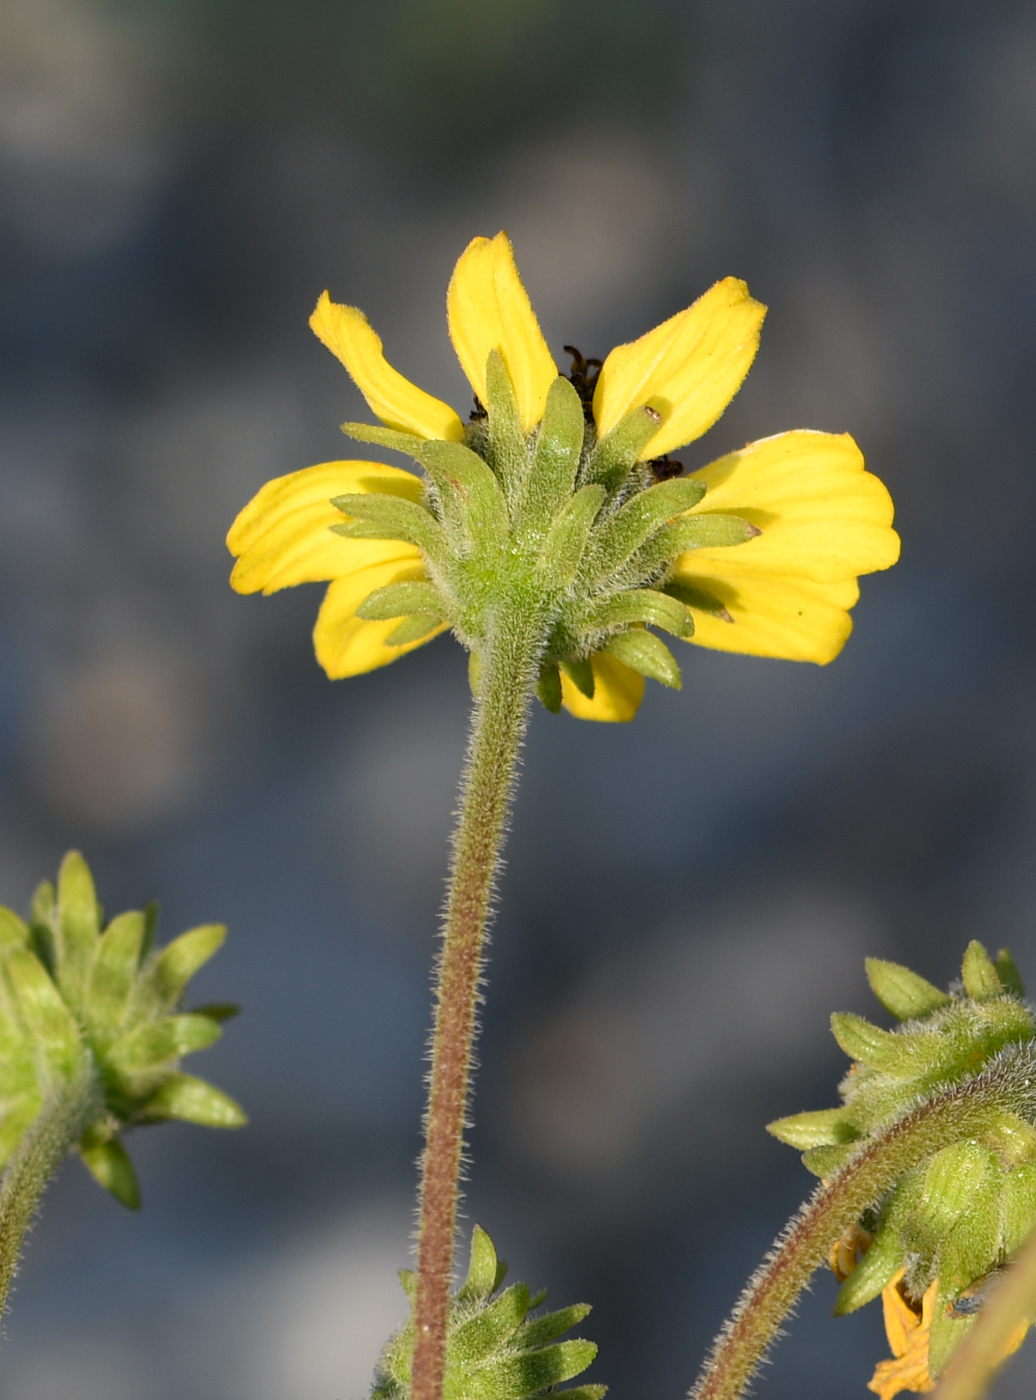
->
[769, 942, 1036, 1375]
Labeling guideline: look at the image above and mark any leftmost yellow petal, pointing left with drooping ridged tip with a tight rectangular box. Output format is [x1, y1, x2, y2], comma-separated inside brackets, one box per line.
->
[227, 462, 421, 594]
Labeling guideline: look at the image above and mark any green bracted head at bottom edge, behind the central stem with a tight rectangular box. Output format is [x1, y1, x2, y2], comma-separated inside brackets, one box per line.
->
[372, 1225, 608, 1400]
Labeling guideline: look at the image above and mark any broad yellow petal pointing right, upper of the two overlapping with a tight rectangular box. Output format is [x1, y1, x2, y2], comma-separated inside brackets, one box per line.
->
[692, 431, 899, 582]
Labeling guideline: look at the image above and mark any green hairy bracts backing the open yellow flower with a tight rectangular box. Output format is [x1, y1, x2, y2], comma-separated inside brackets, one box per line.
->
[332, 350, 759, 710]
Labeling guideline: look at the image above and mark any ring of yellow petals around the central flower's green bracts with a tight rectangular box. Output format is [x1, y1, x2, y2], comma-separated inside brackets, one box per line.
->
[227, 232, 899, 720]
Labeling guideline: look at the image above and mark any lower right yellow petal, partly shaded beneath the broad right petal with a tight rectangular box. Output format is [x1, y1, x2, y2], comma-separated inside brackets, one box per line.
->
[673, 545, 860, 665]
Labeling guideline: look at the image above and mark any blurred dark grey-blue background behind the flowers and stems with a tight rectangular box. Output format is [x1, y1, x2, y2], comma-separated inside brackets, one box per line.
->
[0, 0, 1036, 1400]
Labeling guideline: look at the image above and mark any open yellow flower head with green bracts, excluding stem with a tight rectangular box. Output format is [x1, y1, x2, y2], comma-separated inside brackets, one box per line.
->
[227, 234, 899, 720]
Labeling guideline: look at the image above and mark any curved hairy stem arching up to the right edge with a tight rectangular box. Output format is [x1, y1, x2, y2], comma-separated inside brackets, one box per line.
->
[689, 1047, 1036, 1400]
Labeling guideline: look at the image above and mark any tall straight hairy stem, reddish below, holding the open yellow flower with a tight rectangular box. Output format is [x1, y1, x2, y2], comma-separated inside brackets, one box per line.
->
[410, 609, 542, 1400]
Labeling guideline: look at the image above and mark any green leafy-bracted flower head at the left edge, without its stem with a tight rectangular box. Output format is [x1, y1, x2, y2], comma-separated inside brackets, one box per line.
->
[0, 851, 246, 1208]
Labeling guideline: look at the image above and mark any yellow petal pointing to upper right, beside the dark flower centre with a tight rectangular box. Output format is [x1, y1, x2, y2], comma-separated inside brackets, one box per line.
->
[594, 277, 766, 459]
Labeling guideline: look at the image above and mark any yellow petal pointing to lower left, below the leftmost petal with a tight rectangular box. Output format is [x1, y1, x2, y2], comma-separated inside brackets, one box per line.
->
[314, 559, 447, 680]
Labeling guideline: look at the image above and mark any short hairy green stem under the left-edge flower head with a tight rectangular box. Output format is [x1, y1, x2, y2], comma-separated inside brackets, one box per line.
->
[0, 1056, 98, 1317]
